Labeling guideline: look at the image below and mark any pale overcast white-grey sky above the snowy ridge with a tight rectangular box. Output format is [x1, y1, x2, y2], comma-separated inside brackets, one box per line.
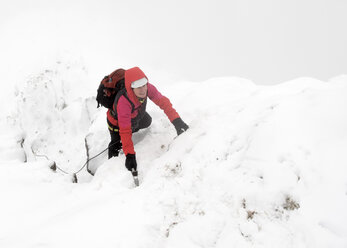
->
[0, 0, 347, 84]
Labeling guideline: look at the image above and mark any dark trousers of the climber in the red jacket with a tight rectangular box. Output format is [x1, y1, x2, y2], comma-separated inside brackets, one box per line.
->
[107, 112, 152, 159]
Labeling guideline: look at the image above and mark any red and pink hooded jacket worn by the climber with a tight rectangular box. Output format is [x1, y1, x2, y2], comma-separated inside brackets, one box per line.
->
[107, 67, 179, 155]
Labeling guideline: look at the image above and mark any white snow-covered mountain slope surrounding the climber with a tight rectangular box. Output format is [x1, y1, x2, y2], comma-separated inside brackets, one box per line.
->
[0, 61, 347, 248]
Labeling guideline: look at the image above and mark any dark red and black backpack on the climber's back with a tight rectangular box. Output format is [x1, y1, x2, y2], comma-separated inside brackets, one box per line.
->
[96, 69, 125, 109]
